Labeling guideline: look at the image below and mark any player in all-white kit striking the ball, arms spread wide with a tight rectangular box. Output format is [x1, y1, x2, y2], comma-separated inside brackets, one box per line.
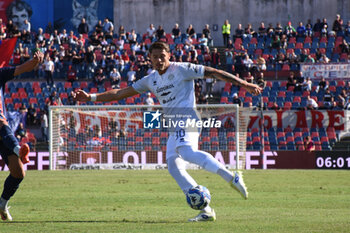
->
[75, 42, 262, 221]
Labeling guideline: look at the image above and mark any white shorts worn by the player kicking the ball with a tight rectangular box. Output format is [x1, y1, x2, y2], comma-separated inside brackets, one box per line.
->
[166, 129, 200, 159]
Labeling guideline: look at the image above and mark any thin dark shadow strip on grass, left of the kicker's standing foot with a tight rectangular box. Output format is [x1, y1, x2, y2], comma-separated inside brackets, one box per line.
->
[3, 219, 183, 224]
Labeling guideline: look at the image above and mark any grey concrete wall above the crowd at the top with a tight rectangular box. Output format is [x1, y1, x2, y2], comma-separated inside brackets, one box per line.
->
[114, 0, 350, 45]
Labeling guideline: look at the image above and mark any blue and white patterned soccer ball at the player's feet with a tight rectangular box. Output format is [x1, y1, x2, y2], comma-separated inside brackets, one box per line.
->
[186, 185, 211, 210]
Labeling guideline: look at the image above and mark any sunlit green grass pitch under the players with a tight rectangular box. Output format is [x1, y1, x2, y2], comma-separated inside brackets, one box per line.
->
[0, 170, 350, 233]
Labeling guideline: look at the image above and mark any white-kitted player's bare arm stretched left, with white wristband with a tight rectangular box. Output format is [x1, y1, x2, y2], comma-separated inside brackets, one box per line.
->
[73, 87, 139, 102]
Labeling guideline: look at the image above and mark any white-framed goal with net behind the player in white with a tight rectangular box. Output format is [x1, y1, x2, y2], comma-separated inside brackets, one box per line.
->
[49, 104, 249, 170]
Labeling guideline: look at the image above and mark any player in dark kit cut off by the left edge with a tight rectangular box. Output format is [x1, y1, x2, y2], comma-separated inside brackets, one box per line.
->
[0, 51, 44, 221]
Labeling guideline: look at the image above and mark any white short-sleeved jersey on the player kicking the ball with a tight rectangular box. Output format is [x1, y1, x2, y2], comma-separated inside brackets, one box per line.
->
[132, 62, 204, 109]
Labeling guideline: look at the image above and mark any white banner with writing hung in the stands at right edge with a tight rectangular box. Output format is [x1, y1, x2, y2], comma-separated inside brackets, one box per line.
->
[300, 64, 350, 79]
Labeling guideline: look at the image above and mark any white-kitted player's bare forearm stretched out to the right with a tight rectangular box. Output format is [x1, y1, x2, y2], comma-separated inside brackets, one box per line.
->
[204, 66, 263, 95]
